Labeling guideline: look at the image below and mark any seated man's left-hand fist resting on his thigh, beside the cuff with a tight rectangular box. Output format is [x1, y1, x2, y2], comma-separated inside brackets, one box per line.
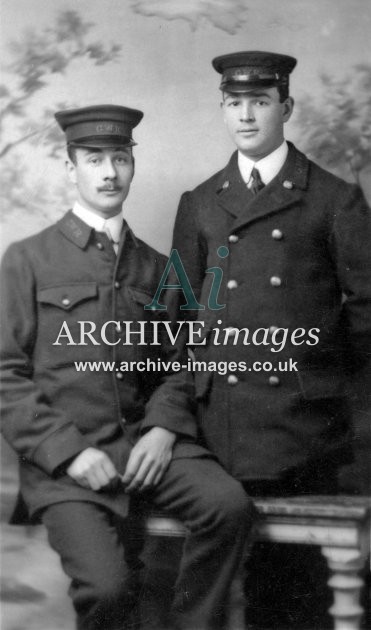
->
[67, 447, 118, 490]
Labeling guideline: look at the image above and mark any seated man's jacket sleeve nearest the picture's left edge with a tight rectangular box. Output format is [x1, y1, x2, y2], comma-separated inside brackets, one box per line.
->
[0, 243, 89, 475]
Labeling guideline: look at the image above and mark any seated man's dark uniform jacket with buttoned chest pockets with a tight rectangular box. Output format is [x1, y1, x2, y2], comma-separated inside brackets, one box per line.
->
[1, 212, 206, 513]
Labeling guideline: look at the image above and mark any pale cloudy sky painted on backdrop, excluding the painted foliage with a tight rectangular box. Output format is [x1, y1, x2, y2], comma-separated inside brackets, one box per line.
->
[0, 0, 371, 251]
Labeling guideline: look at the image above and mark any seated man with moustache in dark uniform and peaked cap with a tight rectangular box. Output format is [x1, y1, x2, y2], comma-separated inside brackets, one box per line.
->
[1, 105, 251, 630]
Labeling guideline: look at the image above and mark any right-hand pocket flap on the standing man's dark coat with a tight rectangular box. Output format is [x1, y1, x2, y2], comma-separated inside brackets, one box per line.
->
[298, 370, 347, 400]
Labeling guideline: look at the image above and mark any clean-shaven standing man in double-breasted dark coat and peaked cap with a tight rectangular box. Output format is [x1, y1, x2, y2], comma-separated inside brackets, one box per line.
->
[173, 51, 371, 630]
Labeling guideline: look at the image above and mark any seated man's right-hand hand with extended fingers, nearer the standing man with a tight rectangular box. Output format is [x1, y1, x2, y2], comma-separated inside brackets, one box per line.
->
[121, 427, 176, 493]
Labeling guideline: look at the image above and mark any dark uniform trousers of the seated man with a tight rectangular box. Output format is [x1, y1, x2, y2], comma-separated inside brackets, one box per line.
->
[43, 457, 254, 630]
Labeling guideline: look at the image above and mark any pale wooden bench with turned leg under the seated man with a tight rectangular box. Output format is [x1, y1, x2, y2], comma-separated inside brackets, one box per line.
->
[146, 496, 371, 630]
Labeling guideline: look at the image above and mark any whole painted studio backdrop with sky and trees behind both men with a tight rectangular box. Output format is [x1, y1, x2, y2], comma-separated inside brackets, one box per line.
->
[0, 0, 371, 630]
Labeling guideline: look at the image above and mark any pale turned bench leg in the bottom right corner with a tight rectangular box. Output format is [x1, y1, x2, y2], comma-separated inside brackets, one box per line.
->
[322, 547, 365, 630]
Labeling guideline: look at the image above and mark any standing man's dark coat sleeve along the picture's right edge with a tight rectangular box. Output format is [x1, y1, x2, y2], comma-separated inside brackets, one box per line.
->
[332, 186, 371, 494]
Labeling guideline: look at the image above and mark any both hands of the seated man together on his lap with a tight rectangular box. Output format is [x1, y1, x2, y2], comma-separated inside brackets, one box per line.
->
[67, 427, 176, 493]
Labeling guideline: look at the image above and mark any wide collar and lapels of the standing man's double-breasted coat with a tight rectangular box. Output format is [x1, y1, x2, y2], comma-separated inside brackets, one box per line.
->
[216, 142, 309, 231]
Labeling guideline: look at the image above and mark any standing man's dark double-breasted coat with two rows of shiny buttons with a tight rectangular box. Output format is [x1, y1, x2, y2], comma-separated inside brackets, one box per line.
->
[173, 145, 371, 488]
